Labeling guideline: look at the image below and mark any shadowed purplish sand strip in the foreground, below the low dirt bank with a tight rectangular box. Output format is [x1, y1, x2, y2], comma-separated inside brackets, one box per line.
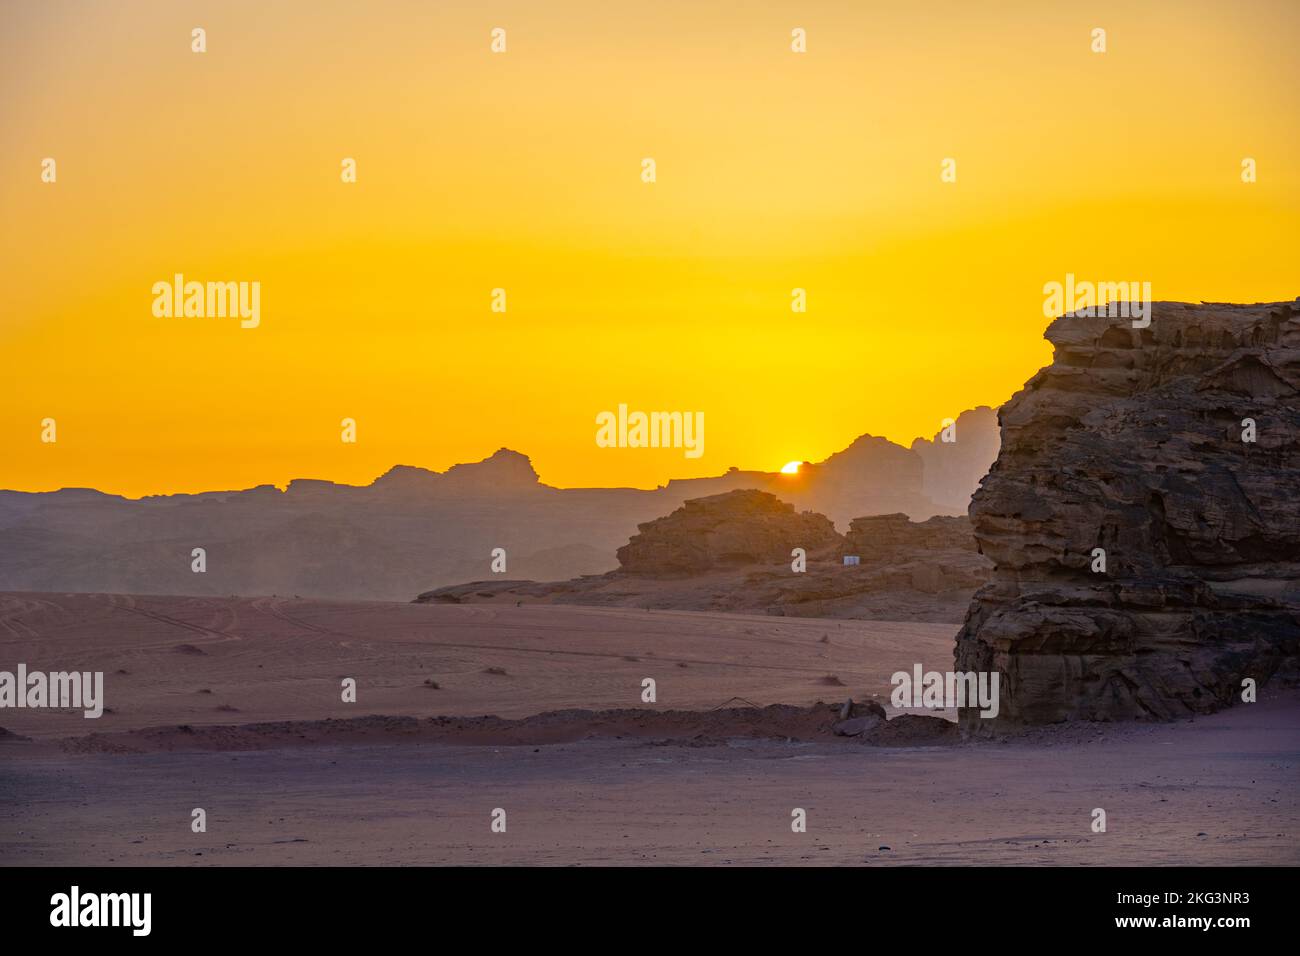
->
[0, 700, 1300, 865]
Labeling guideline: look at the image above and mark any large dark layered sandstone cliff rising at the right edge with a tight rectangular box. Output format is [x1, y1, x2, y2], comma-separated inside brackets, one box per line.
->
[956, 302, 1300, 730]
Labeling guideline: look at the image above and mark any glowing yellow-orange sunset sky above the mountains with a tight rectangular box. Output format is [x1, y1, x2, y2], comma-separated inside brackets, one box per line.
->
[0, 0, 1300, 496]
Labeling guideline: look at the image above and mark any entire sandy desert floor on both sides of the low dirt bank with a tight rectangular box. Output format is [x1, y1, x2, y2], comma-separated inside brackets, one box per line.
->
[0, 594, 1300, 865]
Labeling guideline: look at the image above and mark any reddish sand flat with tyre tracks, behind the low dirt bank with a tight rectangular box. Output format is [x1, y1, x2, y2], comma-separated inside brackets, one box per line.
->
[0, 594, 956, 737]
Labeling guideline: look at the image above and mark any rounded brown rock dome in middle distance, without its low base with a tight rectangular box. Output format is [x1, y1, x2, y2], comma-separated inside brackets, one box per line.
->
[618, 490, 844, 575]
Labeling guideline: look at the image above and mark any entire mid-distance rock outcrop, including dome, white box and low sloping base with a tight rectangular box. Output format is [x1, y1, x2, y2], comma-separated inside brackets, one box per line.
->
[416, 490, 992, 623]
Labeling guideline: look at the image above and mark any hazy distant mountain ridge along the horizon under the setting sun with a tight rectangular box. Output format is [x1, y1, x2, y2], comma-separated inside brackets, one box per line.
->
[0, 410, 996, 601]
